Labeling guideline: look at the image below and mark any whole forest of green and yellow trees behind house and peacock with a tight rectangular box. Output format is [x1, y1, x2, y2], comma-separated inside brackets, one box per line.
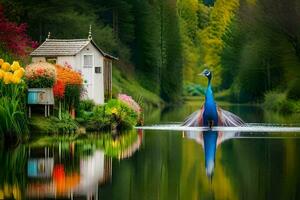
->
[0, 0, 300, 110]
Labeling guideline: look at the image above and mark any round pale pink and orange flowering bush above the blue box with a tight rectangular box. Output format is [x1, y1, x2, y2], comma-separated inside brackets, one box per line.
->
[26, 62, 56, 88]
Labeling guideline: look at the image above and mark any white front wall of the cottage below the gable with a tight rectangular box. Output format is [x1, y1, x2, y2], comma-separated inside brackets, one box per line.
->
[75, 43, 104, 104]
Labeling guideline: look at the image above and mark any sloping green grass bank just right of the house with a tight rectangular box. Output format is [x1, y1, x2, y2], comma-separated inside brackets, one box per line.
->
[113, 67, 163, 107]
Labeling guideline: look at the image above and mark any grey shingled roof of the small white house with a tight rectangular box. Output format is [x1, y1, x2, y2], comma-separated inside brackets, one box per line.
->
[30, 39, 118, 60]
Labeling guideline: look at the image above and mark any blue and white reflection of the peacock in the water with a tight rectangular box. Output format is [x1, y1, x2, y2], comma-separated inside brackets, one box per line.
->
[183, 131, 239, 178]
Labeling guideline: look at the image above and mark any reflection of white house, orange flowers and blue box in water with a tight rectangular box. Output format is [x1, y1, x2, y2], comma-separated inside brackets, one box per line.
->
[26, 147, 112, 199]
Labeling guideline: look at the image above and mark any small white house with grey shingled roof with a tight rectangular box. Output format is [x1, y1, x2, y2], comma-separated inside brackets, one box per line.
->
[30, 29, 118, 104]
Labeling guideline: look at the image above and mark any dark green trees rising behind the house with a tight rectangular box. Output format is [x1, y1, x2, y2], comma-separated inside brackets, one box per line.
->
[1, 0, 183, 102]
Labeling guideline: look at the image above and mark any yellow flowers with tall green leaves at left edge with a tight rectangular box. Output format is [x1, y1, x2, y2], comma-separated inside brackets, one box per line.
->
[0, 59, 28, 138]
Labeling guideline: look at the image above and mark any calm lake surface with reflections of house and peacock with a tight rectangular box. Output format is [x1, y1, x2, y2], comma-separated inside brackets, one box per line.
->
[0, 102, 300, 200]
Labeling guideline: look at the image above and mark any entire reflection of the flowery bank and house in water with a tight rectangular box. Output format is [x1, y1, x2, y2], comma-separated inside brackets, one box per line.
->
[0, 131, 143, 199]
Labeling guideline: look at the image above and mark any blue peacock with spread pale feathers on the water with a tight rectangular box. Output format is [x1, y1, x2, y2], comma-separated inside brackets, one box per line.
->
[182, 69, 245, 128]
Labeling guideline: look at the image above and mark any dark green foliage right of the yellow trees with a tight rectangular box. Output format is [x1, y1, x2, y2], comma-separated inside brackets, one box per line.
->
[221, 0, 300, 103]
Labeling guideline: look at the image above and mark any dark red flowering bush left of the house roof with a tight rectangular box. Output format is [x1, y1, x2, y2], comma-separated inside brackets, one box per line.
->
[0, 5, 37, 56]
